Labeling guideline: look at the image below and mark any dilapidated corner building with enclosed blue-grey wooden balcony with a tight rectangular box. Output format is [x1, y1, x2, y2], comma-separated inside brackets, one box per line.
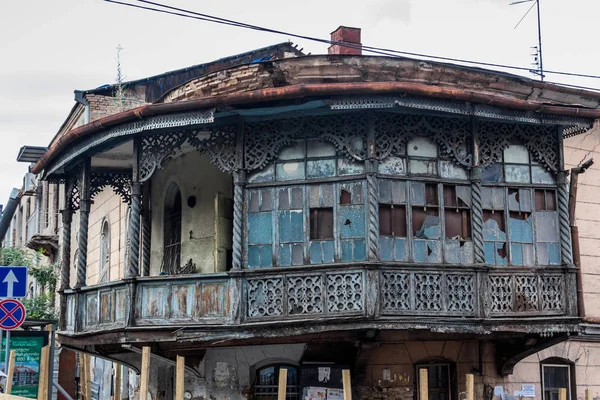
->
[23, 27, 600, 400]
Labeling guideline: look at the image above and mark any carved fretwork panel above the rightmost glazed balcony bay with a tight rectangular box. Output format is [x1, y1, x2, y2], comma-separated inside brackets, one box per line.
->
[478, 121, 559, 173]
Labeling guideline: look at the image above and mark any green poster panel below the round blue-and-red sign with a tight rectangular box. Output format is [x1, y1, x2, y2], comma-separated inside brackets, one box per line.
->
[0, 331, 48, 399]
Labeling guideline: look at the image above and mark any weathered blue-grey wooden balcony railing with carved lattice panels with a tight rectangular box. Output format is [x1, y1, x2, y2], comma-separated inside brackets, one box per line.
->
[64, 265, 577, 334]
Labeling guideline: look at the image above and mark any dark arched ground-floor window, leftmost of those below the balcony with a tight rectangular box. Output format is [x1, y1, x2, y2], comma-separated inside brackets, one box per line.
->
[253, 364, 300, 400]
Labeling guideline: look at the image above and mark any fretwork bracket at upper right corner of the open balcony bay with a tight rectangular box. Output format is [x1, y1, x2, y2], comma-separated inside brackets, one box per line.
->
[189, 125, 242, 173]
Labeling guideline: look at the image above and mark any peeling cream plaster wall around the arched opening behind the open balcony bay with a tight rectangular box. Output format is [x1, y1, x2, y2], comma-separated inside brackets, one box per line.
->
[150, 151, 233, 275]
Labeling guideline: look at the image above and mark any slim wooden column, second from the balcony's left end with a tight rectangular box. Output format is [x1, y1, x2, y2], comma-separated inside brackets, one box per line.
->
[75, 158, 91, 288]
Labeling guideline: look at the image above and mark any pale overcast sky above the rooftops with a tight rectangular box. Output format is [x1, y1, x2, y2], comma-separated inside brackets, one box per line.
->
[0, 0, 600, 204]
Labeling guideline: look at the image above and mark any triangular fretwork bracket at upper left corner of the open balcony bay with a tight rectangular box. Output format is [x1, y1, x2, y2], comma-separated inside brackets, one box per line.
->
[140, 132, 189, 182]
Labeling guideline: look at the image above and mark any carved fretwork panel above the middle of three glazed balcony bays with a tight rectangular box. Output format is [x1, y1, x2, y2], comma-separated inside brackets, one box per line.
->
[375, 113, 473, 167]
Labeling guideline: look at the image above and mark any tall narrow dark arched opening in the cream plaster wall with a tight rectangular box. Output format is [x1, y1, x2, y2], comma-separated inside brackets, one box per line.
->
[161, 183, 182, 274]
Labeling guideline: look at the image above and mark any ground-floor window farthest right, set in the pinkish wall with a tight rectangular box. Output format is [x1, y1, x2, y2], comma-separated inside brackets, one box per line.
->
[540, 357, 577, 400]
